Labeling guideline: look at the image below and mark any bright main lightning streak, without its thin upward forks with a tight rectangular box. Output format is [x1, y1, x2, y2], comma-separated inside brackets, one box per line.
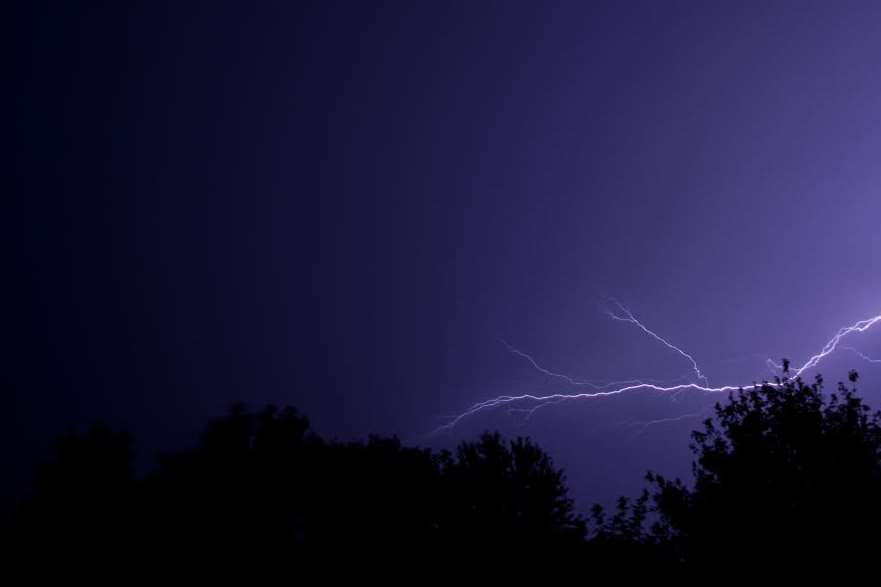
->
[436, 314, 881, 432]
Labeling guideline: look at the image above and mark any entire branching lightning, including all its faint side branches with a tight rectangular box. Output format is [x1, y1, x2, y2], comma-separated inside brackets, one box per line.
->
[437, 308, 881, 431]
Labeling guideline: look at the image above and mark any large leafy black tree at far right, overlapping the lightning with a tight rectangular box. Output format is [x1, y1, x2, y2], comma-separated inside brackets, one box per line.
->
[649, 372, 881, 568]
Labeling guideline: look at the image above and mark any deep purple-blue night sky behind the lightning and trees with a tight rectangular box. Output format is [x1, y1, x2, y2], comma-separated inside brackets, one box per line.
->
[6, 1, 881, 510]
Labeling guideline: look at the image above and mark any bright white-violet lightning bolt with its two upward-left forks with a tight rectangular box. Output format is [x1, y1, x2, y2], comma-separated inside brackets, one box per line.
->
[435, 304, 881, 432]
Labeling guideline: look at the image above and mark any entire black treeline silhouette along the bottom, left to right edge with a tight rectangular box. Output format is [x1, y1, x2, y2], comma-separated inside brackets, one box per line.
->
[7, 373, 881, 570]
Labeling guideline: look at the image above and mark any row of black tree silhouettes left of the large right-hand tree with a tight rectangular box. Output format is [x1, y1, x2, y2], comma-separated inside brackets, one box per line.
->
[13, 406, 584, 561]
